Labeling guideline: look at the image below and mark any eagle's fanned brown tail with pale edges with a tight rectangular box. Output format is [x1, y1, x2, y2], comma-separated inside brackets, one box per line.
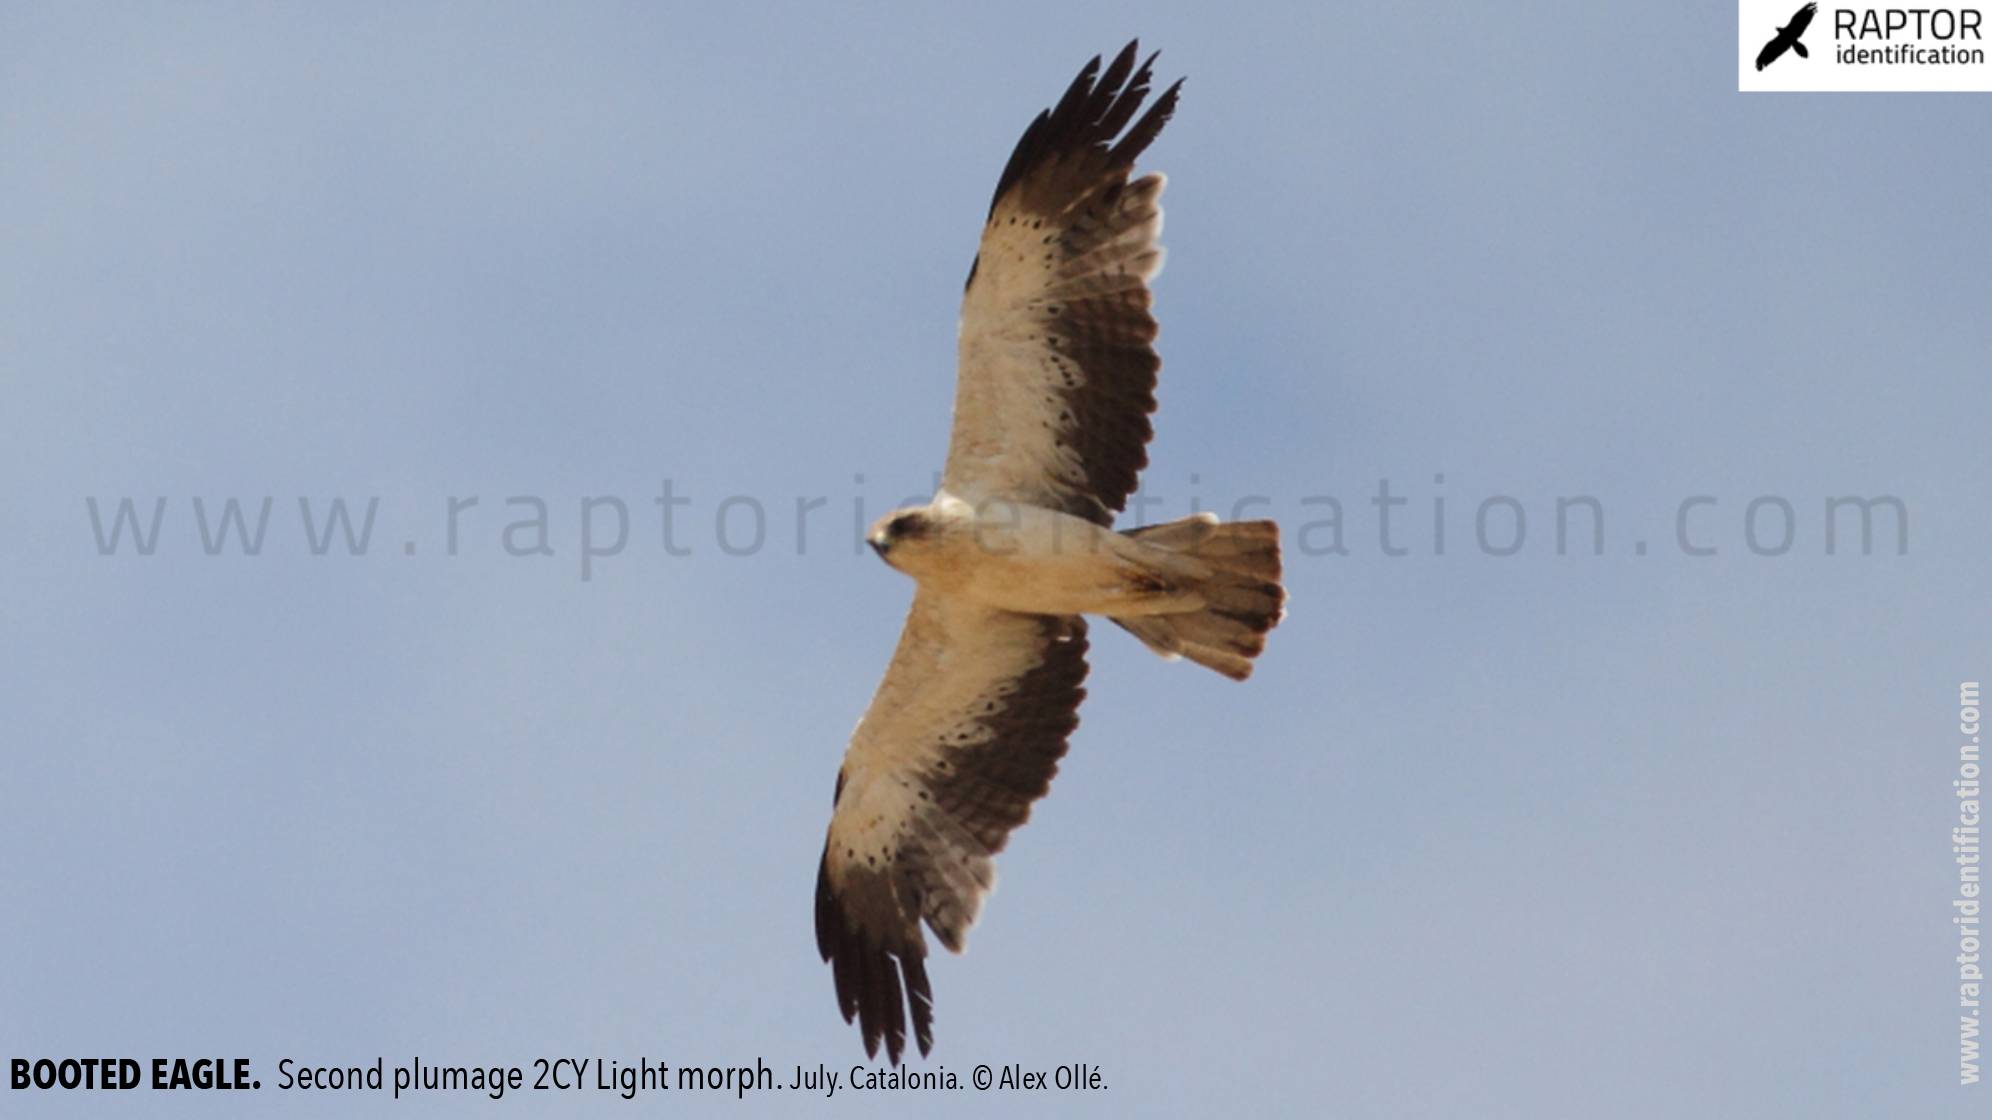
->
[1114, 514, 1287, 680]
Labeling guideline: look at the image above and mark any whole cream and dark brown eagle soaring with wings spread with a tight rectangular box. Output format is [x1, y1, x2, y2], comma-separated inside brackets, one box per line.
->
[817, 42, 1287, 1064]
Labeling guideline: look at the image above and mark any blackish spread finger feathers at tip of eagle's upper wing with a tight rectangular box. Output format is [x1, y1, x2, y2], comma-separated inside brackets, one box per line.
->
[990, 40, 1183, 215]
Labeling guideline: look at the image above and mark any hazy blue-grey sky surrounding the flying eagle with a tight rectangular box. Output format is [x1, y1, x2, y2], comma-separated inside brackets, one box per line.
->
[0, 4, 1992, 1118]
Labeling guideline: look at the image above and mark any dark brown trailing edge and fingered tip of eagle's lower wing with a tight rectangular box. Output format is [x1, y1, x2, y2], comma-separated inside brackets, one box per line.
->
[817, 616, 1086, 1066]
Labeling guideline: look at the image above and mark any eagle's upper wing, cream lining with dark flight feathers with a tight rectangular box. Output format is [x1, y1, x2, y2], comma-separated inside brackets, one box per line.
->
[942, 44, 1181, 524]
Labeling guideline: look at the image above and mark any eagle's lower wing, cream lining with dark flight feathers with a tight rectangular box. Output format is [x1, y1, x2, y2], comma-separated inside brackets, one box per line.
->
[817, 590, 1086, 1064]
